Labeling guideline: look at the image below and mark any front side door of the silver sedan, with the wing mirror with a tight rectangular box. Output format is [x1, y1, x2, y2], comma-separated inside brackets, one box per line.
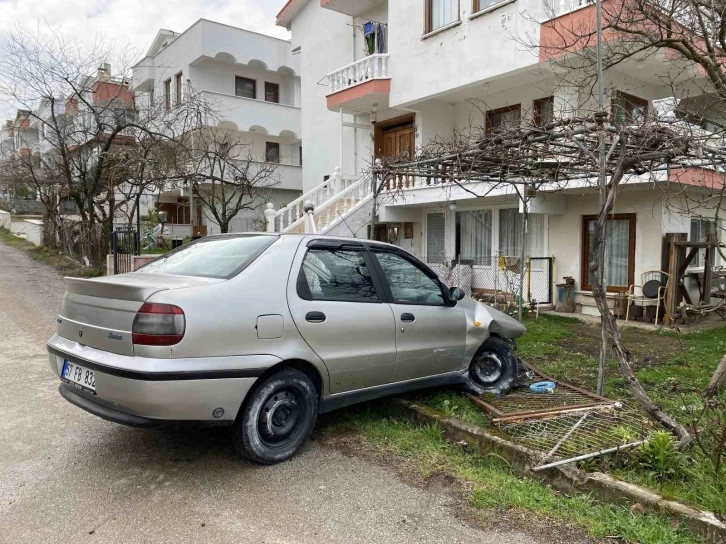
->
[372, 248, 466, 382]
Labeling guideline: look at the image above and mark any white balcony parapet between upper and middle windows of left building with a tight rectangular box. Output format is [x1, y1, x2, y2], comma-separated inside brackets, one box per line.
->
[202, 91, 302, 140]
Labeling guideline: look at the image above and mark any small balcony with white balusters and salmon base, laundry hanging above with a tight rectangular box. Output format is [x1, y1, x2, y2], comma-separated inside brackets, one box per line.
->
[328, 53, 391, 111]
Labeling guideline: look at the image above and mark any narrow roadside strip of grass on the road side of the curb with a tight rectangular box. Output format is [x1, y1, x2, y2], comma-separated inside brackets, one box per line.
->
[318, 400, 697, 544]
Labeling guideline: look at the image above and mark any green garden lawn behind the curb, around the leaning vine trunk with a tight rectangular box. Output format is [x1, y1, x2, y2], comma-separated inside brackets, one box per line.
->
[417, 316, 726, 515]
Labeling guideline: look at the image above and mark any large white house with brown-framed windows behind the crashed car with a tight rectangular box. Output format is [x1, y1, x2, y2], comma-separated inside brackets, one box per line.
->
[272, 0, 726, 312]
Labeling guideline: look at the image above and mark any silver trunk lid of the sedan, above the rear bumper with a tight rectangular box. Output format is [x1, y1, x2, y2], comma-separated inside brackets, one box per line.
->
[58, 273, 224, 355]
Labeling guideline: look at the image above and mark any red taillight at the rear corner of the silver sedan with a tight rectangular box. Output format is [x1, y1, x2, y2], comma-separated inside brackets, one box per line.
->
[131, 302, 186, 346]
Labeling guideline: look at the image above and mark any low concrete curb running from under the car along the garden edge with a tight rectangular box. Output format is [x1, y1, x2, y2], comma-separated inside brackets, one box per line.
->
[395, 399, 726, 544]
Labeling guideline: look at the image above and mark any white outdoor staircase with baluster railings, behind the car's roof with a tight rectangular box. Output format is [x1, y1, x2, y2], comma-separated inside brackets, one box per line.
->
[265, 168, 373, 236]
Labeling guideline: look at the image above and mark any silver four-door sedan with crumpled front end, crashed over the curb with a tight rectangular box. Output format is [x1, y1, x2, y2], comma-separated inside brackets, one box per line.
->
[48, 233, 525, 464]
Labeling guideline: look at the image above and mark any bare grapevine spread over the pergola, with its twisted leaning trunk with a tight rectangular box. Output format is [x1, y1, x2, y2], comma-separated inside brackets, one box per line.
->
[373, 103, 726, 446]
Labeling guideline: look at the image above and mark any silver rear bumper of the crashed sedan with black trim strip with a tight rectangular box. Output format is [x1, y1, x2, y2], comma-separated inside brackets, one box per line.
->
[48, 335, 280, 427]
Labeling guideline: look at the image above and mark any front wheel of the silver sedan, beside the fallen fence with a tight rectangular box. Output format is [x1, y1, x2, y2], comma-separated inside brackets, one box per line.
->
[464, 336, 519, 395]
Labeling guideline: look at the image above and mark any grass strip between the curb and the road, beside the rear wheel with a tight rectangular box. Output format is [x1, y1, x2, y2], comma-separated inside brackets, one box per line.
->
[322, 400, 696, 544]
